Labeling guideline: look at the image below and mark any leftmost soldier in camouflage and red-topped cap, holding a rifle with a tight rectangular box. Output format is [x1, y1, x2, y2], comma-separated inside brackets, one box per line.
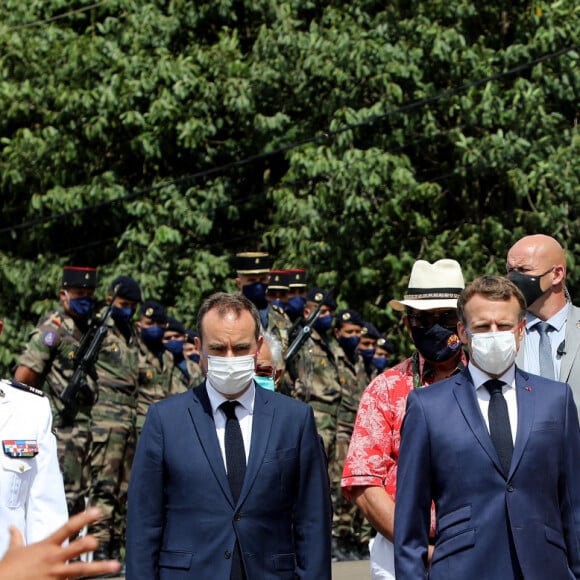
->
[14, 267, 97, 515]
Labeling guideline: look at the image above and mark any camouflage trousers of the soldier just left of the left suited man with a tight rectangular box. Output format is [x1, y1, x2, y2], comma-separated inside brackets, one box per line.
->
[89, 395, 135, 547]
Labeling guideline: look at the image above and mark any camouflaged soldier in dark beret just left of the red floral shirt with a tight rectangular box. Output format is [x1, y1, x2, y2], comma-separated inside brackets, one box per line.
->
[331, 309, 371, 559]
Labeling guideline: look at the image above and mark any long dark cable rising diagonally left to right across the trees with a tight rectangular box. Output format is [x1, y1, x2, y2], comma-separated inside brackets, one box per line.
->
[0, 45, 580, 234]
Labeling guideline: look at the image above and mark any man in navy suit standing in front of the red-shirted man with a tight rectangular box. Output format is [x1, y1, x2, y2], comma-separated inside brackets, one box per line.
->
[395, 276, 580, 580]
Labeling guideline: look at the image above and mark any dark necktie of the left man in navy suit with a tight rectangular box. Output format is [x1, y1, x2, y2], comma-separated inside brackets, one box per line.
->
[220, 401, 246, 580]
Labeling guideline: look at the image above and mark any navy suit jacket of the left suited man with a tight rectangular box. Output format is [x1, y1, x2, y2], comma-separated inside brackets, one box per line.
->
[126, 384, 331, 580]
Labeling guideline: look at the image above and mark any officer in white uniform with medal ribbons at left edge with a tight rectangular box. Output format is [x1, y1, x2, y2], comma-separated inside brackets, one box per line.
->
[0, 376, 68, 558]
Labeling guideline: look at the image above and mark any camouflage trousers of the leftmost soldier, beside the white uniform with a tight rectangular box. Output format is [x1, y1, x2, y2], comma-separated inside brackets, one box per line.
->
[55, 413, 91, 516]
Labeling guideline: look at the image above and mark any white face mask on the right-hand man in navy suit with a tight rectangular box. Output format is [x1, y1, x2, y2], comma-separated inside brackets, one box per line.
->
[469, 330, 518, 376]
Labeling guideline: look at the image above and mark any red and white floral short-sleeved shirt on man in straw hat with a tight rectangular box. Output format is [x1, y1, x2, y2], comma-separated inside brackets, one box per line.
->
[341, 352, 467, 500]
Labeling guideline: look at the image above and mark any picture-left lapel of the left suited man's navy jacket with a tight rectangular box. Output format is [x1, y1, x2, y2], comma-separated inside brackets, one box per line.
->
[189, 382, 234, 505]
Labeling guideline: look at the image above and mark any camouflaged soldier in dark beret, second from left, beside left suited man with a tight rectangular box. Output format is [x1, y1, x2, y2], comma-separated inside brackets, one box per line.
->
[89, 276, 141, 560]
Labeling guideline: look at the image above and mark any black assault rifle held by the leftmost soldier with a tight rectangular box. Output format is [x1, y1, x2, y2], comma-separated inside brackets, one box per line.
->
[60, 287, 118, 425]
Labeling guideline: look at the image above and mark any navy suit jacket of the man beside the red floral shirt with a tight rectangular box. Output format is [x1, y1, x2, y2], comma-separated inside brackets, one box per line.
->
[395, 369, 580, 580]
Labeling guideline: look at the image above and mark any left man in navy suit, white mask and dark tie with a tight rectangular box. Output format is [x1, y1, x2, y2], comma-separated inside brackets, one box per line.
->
[127, 293, 331, 580]
